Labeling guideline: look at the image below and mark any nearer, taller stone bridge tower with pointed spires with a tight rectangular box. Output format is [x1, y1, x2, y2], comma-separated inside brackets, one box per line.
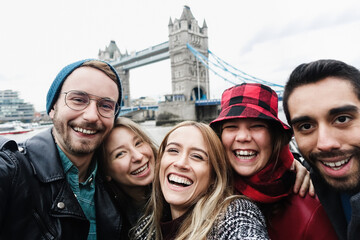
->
[168, 6, 210, 101]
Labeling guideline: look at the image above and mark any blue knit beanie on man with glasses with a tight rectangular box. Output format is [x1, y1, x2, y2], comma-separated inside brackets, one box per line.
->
[46, 59, 122, 118]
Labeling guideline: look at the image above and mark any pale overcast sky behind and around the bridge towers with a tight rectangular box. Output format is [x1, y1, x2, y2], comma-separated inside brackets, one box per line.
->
[0, 0, 360, 111]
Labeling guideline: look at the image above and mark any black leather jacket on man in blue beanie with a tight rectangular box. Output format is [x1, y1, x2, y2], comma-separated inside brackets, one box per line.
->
[0, 129, 122, 239]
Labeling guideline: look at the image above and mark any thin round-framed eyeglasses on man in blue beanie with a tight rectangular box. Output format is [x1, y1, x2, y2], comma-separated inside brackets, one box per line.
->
[62, 90, 119, 118]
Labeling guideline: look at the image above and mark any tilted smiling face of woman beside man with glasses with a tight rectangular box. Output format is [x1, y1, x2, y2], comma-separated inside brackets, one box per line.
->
[105, 127, 155, 187]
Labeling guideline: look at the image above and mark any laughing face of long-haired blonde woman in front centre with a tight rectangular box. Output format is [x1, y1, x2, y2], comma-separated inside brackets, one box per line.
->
[159, 126, 211, 219]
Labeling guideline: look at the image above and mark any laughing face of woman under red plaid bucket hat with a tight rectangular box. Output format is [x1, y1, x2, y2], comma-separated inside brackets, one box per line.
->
[221, 118, 272, 177]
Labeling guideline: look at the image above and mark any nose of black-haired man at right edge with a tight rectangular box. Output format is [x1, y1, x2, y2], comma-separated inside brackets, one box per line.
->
[316, 126, 341, 152]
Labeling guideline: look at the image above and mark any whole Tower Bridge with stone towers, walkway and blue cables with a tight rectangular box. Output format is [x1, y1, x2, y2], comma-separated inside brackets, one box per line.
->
[98, 6, 281, 125]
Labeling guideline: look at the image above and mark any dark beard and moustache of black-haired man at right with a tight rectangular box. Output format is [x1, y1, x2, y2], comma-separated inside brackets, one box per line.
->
[309, 147, 360, 192]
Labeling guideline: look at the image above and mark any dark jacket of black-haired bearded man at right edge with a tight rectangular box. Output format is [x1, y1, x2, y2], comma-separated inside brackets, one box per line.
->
[310, 169, 360, 240]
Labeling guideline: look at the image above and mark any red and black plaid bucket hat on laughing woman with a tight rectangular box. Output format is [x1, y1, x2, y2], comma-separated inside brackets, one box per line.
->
[210, 83, 292, 136]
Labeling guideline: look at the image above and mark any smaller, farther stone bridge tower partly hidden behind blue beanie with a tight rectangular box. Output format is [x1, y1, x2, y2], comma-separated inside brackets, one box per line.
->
[98, 40, 131, 107]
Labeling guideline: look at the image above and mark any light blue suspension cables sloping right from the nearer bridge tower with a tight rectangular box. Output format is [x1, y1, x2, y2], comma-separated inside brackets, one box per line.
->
[186, 43, 284, 96]
